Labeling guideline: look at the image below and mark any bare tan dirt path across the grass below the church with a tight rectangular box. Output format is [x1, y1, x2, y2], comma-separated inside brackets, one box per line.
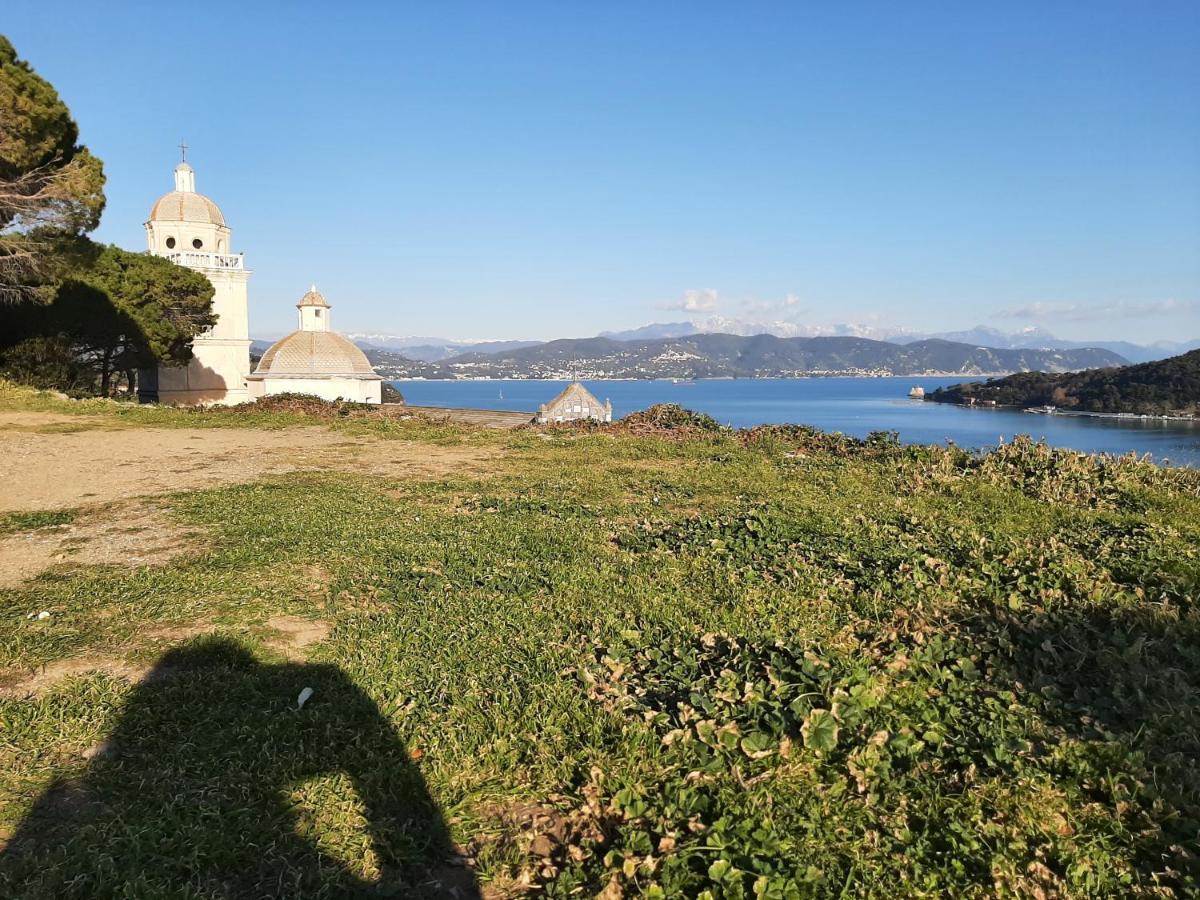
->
[0, 413, 498, 512]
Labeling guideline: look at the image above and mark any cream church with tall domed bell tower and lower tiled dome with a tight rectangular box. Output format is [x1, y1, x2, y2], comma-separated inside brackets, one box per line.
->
[138, 153, 383, 406]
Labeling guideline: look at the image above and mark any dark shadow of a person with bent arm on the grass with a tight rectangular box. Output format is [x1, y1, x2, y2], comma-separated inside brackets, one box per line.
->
[0, 638, 480, 898]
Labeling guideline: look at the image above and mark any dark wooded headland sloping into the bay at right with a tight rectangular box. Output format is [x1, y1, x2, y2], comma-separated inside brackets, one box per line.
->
[925, 350, 1200, 415]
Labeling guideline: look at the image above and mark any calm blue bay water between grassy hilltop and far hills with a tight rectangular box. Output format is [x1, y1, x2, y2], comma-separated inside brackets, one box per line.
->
[395, 378, 1200, 466]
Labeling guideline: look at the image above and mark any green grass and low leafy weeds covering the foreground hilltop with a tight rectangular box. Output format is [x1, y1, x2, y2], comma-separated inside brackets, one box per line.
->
[0, 384, 1200, 899]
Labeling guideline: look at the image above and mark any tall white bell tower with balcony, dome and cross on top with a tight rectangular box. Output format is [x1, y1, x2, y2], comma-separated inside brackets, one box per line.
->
[138, 162, 250, 404]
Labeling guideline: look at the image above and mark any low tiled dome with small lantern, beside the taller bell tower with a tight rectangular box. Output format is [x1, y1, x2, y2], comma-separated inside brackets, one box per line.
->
[247, 286, 383, 403]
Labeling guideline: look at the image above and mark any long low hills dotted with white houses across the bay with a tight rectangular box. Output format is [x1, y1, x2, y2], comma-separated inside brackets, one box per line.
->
[442, 335, 1126, 378]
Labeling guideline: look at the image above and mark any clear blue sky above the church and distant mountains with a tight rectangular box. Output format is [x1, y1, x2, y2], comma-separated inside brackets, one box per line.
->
[7, 0, 1200, 341]
